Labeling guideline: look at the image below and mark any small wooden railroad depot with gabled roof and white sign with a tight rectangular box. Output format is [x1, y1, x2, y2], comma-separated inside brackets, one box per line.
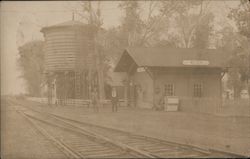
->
[114, 47, 228, 111]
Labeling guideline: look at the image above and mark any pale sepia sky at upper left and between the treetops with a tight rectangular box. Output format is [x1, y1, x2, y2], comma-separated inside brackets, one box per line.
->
[0, 0, 238, 94]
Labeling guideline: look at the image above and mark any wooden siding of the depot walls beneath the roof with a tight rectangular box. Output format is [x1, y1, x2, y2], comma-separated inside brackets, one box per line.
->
[129, 68, 221, 112]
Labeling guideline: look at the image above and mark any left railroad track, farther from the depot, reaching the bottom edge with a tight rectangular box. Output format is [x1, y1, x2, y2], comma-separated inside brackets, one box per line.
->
[18, 110, 148, 158]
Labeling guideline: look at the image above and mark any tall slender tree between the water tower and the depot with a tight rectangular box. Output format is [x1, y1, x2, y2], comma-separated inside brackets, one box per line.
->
[77, 1, 106, 99]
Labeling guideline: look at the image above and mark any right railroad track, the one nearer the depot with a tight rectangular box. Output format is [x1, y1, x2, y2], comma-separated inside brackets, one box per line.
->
[18, 105, 242, 158]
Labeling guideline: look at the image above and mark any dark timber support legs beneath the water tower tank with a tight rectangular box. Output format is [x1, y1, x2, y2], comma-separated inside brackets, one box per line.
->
[47, 70, 104, 105]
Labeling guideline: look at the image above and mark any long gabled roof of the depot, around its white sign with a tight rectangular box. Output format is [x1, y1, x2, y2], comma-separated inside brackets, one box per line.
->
[115, 47, 229, 72]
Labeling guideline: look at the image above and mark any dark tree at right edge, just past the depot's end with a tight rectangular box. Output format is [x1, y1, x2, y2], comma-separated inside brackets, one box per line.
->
[216, 23, 250, 98]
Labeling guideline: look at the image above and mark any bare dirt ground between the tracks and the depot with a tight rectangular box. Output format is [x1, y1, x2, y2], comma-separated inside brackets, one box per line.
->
[19, 99, 250, 156]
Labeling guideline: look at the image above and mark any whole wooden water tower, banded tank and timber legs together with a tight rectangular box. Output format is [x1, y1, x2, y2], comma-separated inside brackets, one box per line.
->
[41, 20, 95, 104]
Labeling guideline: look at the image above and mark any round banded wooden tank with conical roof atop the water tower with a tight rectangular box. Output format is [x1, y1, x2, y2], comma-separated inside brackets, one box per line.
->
[41, 20, 93, 72]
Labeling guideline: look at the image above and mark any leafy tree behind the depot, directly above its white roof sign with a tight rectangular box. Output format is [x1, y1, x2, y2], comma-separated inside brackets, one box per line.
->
[175, 0, 214, 48]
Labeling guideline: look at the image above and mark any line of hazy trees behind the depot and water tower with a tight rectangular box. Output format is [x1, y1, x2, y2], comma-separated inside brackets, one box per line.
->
[18, 0, 250, 97]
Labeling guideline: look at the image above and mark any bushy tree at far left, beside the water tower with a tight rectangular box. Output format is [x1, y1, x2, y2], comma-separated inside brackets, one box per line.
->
[18, 41, 44, 96]
